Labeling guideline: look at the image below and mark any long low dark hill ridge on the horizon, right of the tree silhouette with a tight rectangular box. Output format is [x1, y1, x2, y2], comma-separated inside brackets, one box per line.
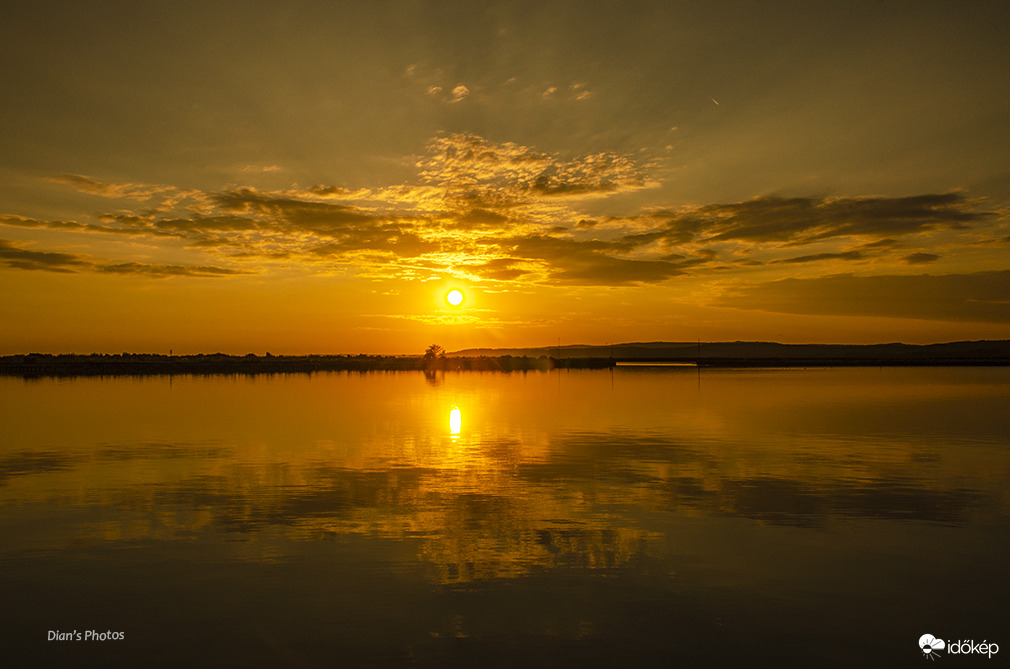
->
[447, 341, 1010, 365]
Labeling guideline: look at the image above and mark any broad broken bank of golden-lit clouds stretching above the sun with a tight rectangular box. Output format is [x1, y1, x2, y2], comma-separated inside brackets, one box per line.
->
[0, 135, 1006, 295]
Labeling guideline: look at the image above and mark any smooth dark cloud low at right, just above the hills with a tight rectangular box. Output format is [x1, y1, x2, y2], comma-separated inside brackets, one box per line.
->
[719, 270, 1010, 323]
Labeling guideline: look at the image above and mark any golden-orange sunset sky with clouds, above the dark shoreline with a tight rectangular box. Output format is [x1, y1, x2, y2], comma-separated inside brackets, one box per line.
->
[0, 0, 1010, 355]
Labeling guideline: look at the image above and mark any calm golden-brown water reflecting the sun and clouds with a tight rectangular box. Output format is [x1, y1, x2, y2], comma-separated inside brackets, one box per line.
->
[0, 368, 1010, 667]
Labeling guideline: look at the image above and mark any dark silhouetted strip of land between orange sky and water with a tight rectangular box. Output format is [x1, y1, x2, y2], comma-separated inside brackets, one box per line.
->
[0, 341, 1010, 378]
